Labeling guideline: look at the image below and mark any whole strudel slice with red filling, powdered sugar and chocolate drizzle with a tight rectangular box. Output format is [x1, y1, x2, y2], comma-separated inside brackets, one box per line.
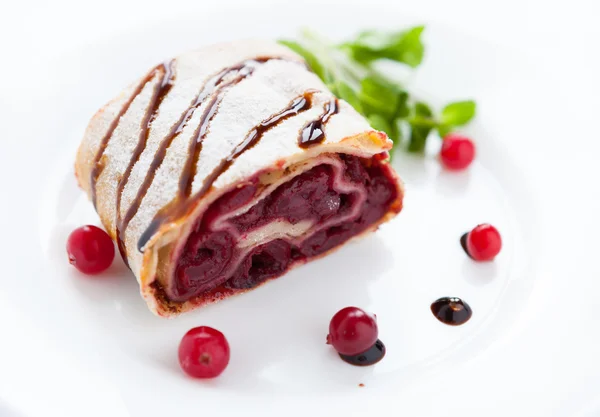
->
[76, 40, 403, 316]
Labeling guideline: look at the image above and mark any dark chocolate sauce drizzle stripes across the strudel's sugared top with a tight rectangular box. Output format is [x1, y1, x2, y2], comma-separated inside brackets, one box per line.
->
[90, 52, 338, 263]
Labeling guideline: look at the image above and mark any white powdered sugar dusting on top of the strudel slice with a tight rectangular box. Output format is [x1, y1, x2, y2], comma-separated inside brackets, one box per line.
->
[77, 40, 398, 314]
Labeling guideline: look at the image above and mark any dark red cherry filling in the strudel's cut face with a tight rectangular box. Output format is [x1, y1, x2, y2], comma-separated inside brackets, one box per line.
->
[167, 155, 398, 301]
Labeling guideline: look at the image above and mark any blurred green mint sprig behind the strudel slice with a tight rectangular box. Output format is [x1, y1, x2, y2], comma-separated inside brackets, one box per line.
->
[280, 26, 476, 152]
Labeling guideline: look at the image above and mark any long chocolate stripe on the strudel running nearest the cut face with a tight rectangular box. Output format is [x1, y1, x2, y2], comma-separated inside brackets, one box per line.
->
[138, 91, 315, 251]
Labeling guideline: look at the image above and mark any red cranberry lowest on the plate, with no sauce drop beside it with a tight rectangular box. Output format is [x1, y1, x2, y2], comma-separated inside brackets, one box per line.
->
[179, 326, 229, 378]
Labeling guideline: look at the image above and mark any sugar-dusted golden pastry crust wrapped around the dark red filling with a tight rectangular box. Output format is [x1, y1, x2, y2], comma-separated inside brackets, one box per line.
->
[75, 40, 402, 316]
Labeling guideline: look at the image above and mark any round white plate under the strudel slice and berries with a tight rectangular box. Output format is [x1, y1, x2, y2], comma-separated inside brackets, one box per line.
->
[0, 1, 600, 417]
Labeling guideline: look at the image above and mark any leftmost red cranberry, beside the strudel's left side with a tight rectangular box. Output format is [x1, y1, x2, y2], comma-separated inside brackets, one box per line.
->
[67, 226, 115, 275]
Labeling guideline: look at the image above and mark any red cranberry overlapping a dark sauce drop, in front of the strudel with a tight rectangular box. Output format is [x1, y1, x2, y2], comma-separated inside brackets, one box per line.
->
[327, 307, 378, 355]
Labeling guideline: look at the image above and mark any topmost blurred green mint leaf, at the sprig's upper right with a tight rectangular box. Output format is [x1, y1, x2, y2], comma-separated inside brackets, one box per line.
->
[341, 26, 425, 68]
